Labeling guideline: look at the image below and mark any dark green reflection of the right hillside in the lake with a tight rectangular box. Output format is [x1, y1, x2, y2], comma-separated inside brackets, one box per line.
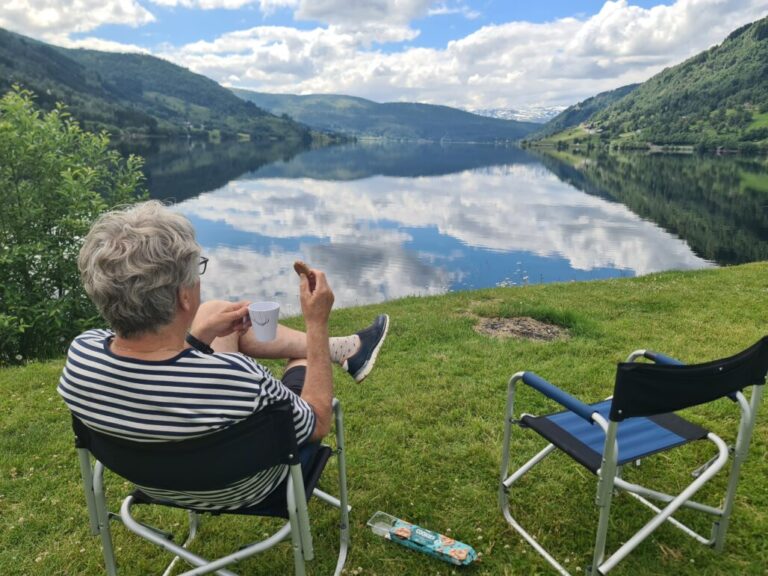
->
[540, 154, 768, 264]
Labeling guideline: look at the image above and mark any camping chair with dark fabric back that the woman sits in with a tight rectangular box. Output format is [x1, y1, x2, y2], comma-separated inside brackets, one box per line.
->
[73, 399, 350, 576]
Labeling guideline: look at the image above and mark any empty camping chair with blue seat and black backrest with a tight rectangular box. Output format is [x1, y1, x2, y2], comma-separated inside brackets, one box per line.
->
[499, 337, 768, 575]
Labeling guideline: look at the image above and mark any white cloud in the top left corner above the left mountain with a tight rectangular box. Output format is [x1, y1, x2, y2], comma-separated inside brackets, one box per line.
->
[0, 0, 155, 44]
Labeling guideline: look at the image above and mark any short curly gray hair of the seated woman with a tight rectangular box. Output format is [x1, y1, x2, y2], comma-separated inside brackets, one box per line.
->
[77, 200, 200, 338]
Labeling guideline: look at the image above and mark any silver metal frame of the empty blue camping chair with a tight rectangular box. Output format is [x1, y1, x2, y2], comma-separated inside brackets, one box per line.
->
[498, 350, 765, 576]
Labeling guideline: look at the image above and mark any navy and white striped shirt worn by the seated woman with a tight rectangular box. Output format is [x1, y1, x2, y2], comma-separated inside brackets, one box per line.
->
[58, 330, 315, 510]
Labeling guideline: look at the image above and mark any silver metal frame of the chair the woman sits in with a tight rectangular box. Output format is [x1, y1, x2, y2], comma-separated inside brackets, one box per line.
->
[77, 398, 352, 576]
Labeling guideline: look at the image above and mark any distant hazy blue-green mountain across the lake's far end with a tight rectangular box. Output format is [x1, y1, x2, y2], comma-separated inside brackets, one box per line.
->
[233, 89, 539, 142]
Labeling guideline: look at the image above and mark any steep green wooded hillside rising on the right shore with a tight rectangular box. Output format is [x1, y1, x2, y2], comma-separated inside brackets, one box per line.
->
[532, 18, 768, 151]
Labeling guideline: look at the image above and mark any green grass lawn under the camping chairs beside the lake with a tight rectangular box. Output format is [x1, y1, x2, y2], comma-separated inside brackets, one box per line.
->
[0, 263, 768, 576]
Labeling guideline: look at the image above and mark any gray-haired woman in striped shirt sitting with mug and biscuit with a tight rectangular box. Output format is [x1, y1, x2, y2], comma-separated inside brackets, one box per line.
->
[58, 201, 389, 509]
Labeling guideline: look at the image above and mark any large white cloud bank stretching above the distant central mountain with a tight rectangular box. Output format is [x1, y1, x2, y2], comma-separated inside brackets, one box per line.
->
[158, 0, 768, 108]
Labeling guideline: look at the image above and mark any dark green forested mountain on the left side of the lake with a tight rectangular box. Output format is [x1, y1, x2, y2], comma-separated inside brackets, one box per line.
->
[0, 28, 310, 141]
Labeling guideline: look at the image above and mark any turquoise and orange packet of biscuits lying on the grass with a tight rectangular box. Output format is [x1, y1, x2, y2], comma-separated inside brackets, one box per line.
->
[368, 512, 477, 566]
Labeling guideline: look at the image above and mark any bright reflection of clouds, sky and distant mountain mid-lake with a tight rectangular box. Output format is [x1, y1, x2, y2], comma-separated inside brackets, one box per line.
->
[164, 145, 710, 314]
